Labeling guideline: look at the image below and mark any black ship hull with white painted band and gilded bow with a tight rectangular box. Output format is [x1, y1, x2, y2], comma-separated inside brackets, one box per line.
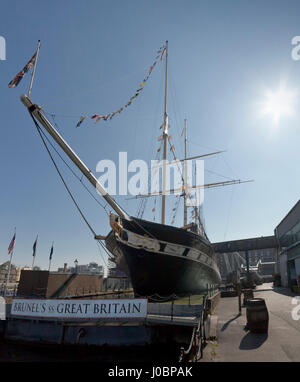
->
[106, 216, 220, 298]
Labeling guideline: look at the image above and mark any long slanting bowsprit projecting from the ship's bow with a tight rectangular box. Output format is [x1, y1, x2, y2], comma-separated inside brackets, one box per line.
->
[21, 94, 131, 220]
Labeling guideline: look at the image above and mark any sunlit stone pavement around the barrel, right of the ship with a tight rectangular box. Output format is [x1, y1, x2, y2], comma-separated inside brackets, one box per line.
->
[200, 284, 300, 362]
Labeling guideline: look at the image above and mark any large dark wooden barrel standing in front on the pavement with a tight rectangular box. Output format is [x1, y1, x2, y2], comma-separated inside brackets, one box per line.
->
[246, 298, 269, 333]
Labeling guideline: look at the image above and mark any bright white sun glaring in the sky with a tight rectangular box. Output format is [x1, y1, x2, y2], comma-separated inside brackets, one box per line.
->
[261, 85, 297, 125]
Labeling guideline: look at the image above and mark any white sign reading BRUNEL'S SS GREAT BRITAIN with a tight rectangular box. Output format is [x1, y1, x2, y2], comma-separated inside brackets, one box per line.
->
[11, 299, 148, 319]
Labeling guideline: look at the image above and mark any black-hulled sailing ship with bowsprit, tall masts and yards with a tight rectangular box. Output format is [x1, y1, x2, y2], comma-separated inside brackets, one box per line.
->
[21, 42, 252, 300]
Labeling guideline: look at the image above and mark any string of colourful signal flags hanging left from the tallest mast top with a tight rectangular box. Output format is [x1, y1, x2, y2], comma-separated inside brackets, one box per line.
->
[76, 45, 166, 127]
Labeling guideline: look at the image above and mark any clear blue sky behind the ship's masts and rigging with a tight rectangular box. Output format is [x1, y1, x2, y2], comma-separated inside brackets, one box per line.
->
[0, 0, 300, 270]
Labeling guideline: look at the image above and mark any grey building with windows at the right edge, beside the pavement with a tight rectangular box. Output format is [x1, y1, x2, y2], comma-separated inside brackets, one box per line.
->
[275, 200, 300, 287]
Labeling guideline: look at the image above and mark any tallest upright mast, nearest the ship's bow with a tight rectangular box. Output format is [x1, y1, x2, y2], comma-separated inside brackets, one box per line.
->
[161, 41, 168, 224]
